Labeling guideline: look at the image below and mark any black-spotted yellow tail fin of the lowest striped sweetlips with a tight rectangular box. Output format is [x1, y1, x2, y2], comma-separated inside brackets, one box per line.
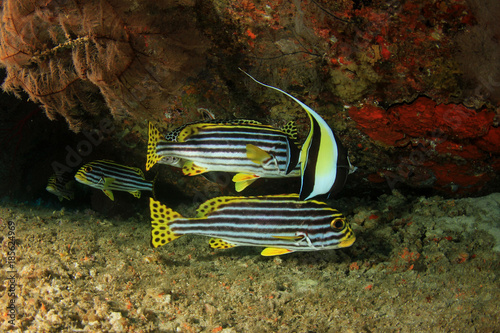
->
[149, 198, 182, 247]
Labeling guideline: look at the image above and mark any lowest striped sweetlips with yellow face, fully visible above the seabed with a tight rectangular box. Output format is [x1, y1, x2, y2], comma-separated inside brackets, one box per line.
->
[149, 194, 356, 256]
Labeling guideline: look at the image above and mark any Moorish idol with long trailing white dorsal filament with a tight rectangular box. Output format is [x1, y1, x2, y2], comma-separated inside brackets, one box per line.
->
[242, 71, 355, 200]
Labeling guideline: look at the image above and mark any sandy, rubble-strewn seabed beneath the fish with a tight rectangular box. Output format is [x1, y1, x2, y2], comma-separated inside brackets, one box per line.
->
[0, 192, 500, 333]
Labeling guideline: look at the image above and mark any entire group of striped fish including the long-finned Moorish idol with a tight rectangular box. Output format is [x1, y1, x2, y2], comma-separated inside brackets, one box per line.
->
[47, 72, 356, 256]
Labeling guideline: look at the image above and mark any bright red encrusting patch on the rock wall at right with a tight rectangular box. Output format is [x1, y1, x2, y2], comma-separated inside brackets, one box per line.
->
[349, 97, 500, 159]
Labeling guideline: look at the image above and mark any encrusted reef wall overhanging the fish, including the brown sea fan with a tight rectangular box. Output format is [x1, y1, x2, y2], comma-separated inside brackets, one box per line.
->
[0, 0, 500, 195]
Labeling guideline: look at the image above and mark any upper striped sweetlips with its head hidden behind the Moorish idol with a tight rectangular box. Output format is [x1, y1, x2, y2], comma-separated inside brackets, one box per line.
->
[146, 119, 300, 192]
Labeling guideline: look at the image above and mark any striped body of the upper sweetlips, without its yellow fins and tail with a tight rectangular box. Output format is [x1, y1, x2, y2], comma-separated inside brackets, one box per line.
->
[156, 123, 300, 177]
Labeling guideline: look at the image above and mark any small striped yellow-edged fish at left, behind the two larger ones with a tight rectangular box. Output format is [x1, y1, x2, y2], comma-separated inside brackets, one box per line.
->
[75, 160, 153, 200]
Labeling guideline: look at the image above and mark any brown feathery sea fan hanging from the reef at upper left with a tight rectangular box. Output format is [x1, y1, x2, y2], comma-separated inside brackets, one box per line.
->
[0, 0, 209, 130]
